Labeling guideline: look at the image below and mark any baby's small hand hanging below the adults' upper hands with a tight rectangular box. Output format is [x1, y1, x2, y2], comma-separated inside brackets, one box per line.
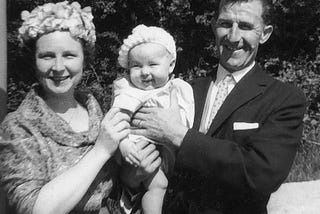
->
[119, 138, 140, 166]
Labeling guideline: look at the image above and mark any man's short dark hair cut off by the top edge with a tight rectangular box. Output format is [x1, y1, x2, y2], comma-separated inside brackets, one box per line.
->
[219, 0, 273, 25]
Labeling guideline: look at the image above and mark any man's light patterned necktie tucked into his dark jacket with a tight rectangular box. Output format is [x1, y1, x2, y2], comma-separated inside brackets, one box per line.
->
[200, 74, 234, 133]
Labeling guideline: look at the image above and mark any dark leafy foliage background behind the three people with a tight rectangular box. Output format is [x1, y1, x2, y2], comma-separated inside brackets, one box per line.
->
[7, 0, 320, 204]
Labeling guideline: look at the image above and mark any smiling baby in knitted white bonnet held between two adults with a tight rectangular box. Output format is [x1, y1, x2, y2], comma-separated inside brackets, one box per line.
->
[113, 25, 194, 214]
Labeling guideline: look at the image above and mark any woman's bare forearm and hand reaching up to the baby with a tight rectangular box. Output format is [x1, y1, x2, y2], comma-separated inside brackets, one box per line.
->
[33, 108, 130, 214]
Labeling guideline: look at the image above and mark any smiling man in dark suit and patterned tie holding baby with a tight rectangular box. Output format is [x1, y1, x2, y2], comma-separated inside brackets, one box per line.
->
[132, 0, 305, 214]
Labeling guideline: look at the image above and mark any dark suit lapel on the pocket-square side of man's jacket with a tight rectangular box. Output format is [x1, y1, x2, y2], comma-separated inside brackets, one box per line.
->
[207, 63, 273, 135]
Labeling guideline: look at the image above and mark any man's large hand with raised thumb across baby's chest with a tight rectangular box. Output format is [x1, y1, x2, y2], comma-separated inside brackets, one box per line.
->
[132, 89, 188, 147]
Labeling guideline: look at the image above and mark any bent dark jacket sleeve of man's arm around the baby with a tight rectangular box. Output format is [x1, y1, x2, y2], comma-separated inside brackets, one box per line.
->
[177, 85, 306, 193]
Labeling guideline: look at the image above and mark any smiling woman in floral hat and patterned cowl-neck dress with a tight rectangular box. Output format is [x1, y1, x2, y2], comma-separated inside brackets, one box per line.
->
[0, 1, 157, 214]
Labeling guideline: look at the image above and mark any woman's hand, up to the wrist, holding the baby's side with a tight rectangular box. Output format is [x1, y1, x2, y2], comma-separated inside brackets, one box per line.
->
[95, 108, 130, 157]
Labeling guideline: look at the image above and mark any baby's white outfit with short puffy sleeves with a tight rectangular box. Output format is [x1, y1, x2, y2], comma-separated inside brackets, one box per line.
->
[112, 77, 195, 174]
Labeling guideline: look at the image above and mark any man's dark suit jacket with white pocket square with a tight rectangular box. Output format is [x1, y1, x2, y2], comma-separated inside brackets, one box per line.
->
[176, 63, 306, 214]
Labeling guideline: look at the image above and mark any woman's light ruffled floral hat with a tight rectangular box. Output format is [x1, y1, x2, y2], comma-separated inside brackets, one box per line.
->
[19, 1, 96, 46]
